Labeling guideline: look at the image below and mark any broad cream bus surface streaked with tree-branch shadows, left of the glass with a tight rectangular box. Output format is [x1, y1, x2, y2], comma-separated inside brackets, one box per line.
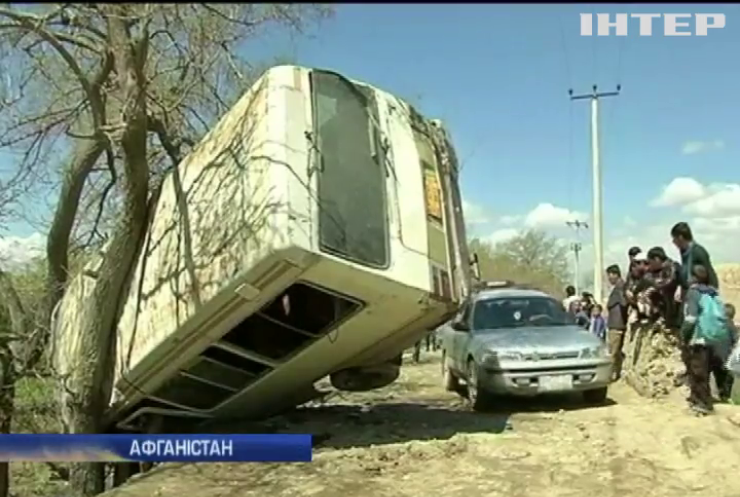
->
[112, 67, 290, 386]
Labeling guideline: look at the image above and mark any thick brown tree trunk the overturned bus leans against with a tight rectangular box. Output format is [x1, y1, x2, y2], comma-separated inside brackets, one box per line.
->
[68, 4, 149, 496]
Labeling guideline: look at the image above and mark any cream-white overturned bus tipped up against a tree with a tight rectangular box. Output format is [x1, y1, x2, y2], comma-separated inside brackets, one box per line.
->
[54, 66, 471, 431]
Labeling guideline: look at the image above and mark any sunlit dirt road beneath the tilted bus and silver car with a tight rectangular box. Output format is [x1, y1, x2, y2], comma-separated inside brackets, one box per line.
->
[107, 350, 740, 497]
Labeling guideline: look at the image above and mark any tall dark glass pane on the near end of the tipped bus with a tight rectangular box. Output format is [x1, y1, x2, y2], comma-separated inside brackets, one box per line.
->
[311, 71, 390, 267]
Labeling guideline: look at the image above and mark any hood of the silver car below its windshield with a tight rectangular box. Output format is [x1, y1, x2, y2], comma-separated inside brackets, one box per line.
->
[476, 325, 602, 352]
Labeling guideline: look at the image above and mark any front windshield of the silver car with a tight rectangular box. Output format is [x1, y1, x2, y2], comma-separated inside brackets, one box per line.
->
[473, 297, 575, 330]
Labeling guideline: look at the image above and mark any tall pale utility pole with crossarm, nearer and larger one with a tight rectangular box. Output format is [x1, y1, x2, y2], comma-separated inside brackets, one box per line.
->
[568, 85, 622, 304]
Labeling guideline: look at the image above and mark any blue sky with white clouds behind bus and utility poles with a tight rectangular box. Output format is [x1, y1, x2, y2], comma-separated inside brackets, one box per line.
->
[0, 4, 740, 276]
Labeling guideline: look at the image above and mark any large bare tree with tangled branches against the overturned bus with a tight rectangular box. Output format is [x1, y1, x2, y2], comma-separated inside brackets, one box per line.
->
[0, 4, 330, 495]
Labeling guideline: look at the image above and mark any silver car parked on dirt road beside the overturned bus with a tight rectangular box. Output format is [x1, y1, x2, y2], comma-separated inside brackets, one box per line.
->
[439, 287, 612, 409]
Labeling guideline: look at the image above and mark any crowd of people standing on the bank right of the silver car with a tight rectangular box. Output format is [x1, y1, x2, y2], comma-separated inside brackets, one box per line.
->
[563, 222, 738, 415]
